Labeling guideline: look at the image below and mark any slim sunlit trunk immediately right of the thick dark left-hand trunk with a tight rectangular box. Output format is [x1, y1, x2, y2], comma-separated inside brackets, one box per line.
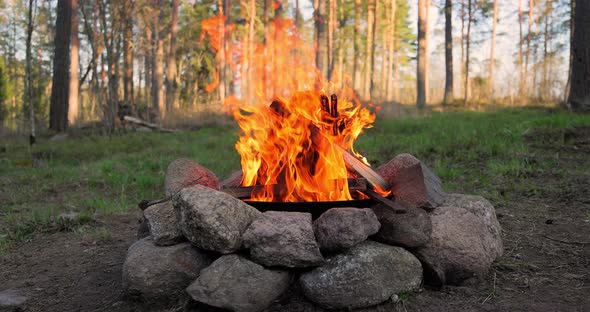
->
[68, 0, 80, 125]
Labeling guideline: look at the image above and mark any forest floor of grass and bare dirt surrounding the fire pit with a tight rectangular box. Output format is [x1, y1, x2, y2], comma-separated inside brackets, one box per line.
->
[0, 108, 590, 311]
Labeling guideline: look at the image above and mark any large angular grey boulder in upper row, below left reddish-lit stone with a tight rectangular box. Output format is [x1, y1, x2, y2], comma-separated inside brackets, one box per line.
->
[172, 185, 261, 254]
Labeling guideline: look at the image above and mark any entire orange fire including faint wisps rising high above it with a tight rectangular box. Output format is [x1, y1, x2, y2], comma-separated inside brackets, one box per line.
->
[201, 16, 375, 202]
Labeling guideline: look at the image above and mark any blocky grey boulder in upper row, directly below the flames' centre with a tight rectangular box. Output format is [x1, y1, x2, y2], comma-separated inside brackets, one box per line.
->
[244, 211, 324, 268]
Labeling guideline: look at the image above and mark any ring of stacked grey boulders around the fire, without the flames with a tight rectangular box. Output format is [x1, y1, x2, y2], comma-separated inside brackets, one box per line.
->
[123, 154, 502, 311]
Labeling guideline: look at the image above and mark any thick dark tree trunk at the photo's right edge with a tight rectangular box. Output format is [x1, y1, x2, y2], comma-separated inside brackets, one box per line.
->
[569, 1, 590, 112]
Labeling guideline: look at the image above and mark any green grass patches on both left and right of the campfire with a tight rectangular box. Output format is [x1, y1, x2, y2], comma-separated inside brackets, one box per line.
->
[0, 110, 590, 248]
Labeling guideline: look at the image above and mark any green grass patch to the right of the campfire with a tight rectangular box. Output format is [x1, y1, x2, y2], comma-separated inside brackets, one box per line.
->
[355, 110, 590, 198]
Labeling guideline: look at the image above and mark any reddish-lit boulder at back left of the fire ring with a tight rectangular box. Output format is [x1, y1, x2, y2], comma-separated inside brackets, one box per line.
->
[164, 158, 219, 196]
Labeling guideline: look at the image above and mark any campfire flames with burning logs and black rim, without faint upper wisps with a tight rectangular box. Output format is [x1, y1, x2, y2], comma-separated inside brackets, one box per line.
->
[221, 91, 405, 217]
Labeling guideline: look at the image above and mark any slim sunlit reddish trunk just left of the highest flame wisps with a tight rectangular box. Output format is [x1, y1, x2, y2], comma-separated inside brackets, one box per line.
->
[166, 0, 178, 111]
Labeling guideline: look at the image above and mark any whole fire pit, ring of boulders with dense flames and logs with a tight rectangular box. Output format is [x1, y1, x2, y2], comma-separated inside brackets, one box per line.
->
[123, 92, 502, 311]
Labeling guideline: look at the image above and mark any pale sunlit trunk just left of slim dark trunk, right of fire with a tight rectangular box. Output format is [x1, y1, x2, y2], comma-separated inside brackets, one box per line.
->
[416, 0, 429, 109]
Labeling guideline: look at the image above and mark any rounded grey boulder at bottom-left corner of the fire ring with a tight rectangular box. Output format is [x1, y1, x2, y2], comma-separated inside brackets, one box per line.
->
[123, 238, 214, 301]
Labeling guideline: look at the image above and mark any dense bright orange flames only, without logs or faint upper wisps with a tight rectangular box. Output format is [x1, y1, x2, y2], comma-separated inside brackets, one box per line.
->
[234, 91, 375, 202]
